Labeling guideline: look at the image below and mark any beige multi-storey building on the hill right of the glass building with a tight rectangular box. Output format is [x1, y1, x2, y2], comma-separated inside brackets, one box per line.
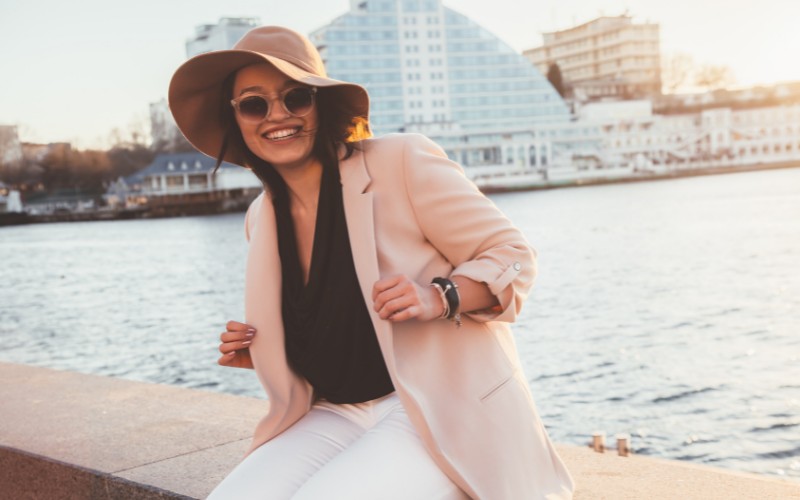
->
[523, 15, 661, 101]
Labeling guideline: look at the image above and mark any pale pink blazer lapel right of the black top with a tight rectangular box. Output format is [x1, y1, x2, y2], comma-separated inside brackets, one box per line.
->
[339, 146, 396, 374]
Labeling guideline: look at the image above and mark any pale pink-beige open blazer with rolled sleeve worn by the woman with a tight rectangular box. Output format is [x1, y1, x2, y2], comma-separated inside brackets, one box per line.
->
[245, 134, 573, 500]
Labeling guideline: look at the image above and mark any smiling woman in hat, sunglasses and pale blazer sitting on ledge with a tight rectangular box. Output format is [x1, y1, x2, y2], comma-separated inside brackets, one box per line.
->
[169, 27, 572, 500]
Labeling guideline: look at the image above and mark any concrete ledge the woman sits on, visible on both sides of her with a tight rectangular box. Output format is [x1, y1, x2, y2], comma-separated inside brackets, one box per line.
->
[0, 363, 800, 500]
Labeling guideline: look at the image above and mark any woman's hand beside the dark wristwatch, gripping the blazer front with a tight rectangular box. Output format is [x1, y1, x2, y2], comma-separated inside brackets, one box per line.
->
[372, 274, 444, 321]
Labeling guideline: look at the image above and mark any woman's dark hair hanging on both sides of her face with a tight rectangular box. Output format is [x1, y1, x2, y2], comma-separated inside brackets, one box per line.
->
[214, 72, 372, 201]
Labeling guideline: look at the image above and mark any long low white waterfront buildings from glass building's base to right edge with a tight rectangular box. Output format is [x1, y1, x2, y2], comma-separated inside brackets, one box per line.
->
[444, 94, 800, 192]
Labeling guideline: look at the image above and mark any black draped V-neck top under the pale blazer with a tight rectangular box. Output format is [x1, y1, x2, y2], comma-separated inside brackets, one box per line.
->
[274, 165, 394, 404]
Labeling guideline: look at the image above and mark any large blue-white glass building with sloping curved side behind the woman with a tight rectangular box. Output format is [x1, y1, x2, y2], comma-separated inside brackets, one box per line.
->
[311, 0, 570, 138]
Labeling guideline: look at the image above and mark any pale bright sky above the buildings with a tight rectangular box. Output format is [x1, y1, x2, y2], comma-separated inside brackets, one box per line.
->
[0, 0, 800, 148]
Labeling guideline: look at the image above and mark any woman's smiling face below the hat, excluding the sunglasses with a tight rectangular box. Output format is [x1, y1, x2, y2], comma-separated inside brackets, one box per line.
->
[232, 63, 318, 176]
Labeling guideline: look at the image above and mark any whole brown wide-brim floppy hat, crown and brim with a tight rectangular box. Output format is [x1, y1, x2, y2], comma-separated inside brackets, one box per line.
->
[169, 26, 369, 165]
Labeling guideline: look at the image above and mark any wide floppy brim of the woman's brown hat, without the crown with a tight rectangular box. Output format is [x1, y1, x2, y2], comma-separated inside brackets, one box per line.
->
[168, 49, 369, 166]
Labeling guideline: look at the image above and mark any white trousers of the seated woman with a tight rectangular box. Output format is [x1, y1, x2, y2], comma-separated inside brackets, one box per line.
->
[208, 393, 469, 500]
